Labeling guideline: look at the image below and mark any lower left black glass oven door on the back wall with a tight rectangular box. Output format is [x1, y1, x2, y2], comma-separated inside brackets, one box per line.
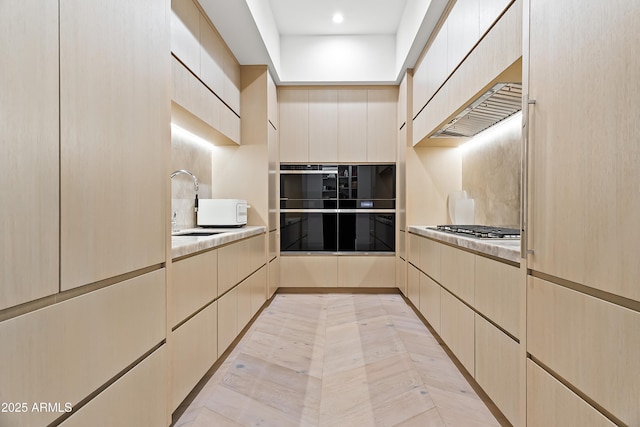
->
[280, 209, 338, 253]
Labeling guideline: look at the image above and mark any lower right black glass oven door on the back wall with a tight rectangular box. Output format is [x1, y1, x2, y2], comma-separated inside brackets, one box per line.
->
[338, 209, 396, 253]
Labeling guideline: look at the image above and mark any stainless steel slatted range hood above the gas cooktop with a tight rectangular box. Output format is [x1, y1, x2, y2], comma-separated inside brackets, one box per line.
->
[431, 83, 522, 138]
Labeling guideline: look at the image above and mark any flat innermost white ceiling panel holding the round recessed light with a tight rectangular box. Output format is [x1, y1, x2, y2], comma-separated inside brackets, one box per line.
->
[269, 0, 407, 36]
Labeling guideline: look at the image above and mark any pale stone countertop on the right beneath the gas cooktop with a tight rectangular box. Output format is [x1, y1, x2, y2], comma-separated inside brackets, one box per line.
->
[408, 225, 520, 263]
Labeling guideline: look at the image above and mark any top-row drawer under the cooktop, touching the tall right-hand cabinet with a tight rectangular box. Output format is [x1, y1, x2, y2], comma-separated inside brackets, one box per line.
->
[475, 256, 524, 338]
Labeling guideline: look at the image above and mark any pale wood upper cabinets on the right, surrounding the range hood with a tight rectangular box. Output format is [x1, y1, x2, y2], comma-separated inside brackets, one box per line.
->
[412, 0, 522, 146]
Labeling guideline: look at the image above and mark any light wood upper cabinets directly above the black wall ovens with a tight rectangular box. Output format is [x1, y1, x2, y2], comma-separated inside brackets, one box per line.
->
[278, 87, 398, 163]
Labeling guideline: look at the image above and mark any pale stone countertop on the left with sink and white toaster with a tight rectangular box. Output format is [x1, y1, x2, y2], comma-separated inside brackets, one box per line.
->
[171, 225, 267, 259]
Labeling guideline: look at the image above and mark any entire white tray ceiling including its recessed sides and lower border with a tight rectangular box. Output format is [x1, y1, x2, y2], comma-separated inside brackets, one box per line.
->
[199, 0, 449, 85]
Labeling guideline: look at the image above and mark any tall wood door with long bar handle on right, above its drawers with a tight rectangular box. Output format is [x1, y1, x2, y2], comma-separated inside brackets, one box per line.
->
[528, 0, 640, 300]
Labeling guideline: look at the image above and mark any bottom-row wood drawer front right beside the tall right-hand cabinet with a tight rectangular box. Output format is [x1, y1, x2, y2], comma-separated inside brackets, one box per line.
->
[475, 314, 520, 425]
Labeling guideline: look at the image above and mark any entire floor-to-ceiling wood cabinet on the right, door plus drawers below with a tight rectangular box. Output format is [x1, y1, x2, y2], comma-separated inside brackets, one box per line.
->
[524, 0, 640, 425]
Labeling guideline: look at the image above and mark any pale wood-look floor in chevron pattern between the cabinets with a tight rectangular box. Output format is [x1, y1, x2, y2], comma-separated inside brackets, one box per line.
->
[174, 294, 508, 427]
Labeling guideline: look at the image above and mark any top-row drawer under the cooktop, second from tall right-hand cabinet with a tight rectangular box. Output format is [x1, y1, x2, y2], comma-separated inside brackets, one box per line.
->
[440, 245, 476, 305]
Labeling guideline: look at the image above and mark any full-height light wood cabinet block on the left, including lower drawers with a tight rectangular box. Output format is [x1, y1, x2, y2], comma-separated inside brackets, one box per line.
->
[0, 0, 170, 427]
